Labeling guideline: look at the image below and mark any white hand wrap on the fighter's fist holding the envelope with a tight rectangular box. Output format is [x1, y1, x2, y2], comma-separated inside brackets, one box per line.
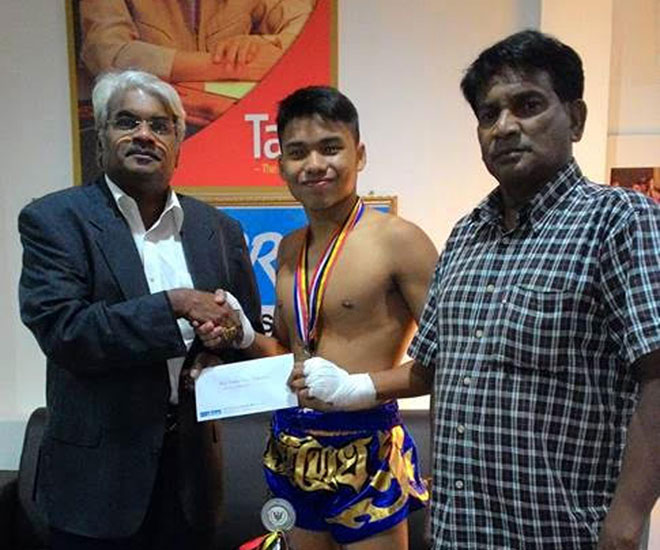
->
[303, 357, 377, 411]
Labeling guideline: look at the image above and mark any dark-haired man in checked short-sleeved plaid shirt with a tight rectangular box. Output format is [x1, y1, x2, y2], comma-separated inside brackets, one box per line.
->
[296, 31, 660, 550]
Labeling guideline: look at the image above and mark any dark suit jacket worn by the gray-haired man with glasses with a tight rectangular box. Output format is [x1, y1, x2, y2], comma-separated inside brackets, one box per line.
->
[19, 179, 260, 538]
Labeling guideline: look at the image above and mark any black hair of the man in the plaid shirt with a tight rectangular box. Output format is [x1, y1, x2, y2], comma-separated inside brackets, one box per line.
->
[461, 30, 584, 112]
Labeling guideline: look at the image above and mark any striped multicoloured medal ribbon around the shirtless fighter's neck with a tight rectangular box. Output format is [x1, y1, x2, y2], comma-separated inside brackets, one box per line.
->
[293, 198, 364, 350]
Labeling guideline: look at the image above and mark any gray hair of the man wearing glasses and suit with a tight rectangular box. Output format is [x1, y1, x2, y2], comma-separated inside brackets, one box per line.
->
[92, 70, 186, 143]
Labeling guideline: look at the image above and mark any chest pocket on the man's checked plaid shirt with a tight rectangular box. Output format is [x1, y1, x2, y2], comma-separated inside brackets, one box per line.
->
[491, 285, 580, 373]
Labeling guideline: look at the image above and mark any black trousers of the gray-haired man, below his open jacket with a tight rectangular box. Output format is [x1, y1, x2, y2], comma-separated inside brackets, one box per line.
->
[50, 428, 212, 550]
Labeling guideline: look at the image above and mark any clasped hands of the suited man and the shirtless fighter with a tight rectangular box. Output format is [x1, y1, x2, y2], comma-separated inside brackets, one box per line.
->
[167, 289, 255, 349]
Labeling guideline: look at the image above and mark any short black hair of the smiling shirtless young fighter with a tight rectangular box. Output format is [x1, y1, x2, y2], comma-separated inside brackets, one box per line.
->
[277, 86, 360, 143]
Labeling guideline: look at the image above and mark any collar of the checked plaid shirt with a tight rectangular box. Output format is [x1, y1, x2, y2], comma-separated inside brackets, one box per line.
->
[471, 159, 583, 232]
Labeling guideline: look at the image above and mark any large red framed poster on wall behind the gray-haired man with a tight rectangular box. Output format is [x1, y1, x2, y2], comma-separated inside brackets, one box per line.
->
[66, 0, 337, 196]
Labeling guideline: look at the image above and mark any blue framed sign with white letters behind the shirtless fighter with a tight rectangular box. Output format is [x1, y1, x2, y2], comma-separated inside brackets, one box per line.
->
[213, 195, 397, 331]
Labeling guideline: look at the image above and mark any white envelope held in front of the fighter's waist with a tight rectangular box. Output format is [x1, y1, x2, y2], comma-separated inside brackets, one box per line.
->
[195, 353, 298, 422]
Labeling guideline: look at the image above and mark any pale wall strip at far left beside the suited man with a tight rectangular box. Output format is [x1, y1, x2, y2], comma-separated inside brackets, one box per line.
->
[0, 0, 71, 468]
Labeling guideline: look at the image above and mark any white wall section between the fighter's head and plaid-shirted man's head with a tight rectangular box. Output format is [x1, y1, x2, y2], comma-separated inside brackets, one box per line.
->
[339, 0, 540, 246]
